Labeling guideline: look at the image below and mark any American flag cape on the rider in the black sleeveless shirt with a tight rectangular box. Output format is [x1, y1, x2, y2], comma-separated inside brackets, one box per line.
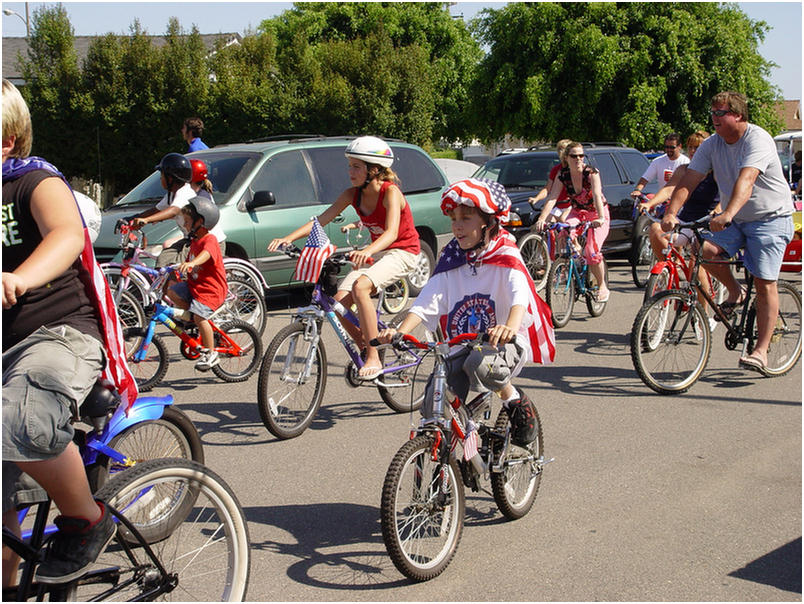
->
[3, 157, 138, 410]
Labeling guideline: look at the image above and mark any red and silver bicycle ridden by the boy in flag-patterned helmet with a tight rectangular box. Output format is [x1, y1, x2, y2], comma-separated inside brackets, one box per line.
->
[380, 334, 552, 581]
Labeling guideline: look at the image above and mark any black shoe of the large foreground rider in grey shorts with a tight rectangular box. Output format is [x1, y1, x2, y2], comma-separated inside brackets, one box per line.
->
[34, 501, 117, 584]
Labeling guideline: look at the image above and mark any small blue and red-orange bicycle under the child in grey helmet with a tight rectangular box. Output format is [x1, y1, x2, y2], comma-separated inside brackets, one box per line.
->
[123, 286, 262, 392]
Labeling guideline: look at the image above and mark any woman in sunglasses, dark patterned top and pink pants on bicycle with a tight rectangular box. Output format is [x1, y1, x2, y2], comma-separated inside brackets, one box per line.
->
[536, 142, 611, 302]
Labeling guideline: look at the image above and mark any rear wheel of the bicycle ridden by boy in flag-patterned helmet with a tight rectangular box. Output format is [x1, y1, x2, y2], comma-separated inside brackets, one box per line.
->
[491, 409, 544, 520]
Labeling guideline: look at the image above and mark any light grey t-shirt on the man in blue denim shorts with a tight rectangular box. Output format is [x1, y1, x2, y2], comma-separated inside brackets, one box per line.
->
[690, 124, 793, 222]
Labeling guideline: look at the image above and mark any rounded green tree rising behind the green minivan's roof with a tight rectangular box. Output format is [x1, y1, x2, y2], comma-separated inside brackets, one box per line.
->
[260, 2, 481, 142]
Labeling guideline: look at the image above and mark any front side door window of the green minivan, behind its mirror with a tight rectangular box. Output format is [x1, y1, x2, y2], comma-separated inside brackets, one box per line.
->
[250, 151, 317, 206]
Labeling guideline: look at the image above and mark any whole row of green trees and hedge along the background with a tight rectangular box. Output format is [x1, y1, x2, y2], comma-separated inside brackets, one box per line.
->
[11, 2, 779, 194]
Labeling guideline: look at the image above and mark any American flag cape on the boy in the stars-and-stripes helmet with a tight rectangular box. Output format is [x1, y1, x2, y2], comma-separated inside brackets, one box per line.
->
[433, 229, 556, 365]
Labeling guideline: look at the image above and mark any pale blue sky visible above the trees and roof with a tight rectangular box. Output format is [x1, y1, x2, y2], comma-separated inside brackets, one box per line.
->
[1, 0, 802, 99]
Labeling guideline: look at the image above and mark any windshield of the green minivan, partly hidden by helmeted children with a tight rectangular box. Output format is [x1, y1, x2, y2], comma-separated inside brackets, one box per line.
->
[115, 151, 259, 206]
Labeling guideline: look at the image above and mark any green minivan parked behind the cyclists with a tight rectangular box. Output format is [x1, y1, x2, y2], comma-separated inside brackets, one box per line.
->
[95, 135, 452, 295]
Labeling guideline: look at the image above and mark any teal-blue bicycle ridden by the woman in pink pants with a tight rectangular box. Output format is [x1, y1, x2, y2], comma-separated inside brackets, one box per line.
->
[545, 222, 608, 328]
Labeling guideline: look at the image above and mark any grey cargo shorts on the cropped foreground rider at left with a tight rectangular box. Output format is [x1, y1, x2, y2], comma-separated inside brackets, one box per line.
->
[3, 325, 104, 511]
